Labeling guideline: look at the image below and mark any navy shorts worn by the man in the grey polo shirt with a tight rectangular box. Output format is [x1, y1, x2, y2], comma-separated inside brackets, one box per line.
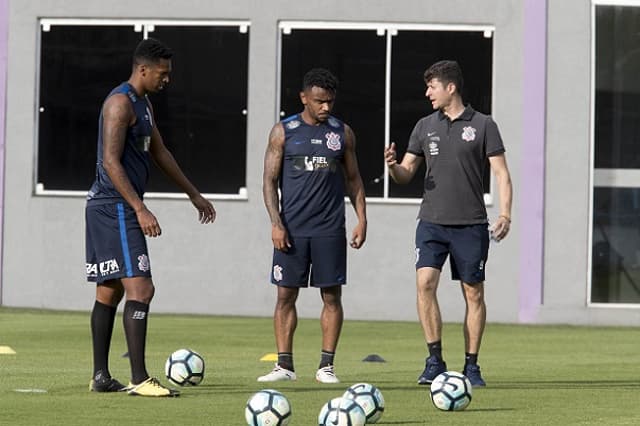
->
[416, 220, 489, 284]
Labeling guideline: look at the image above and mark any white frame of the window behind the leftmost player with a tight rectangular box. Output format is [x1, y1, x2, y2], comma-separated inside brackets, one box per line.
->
[32, 18, 251, 201]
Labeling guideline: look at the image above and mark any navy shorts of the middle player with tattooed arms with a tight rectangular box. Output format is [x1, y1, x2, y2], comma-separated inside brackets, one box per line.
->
[271, 236, 347, 287]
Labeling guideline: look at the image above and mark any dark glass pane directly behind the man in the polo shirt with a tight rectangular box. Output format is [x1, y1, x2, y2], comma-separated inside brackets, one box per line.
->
[388, 31, 493, 197]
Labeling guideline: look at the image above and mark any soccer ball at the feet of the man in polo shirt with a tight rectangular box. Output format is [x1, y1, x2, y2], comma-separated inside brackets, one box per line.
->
[431, 371, 472, 411]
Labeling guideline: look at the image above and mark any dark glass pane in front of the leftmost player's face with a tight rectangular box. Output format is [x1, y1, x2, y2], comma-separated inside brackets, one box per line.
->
[148, 25, 249, 194]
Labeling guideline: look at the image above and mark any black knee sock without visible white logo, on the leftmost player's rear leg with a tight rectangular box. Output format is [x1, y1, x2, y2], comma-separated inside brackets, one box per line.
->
[91, 300, 116, 377]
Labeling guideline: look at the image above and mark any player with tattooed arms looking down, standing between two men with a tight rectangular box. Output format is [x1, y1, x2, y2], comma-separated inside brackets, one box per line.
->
[258, 68, 367, 383]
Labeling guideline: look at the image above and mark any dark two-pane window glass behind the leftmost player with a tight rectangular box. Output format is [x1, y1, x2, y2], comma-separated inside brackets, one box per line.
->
[36, 22, 249, 195]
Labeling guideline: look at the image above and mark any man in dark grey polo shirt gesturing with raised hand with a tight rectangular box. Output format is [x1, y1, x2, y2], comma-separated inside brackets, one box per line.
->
[384, 61, 512, 386]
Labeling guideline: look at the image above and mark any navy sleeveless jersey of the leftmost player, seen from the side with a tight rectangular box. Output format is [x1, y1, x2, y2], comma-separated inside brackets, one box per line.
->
[87, 82, 153, 204]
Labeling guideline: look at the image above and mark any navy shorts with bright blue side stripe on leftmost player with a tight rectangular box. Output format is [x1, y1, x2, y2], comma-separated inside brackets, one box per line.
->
[85, 203, 151, 283]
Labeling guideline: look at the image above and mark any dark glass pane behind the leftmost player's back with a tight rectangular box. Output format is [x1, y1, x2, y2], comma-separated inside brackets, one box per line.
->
[37, 25, 142, 191]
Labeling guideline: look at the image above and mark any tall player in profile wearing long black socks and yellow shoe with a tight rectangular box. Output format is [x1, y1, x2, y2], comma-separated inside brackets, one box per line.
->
[85, 38, 216, 397]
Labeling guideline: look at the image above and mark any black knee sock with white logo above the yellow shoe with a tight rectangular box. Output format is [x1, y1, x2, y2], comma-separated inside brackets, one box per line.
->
[123, 300, 149, 385]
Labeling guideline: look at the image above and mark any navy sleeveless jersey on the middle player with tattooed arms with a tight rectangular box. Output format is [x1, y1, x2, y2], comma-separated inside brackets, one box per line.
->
[280, 114, 345, 237]
